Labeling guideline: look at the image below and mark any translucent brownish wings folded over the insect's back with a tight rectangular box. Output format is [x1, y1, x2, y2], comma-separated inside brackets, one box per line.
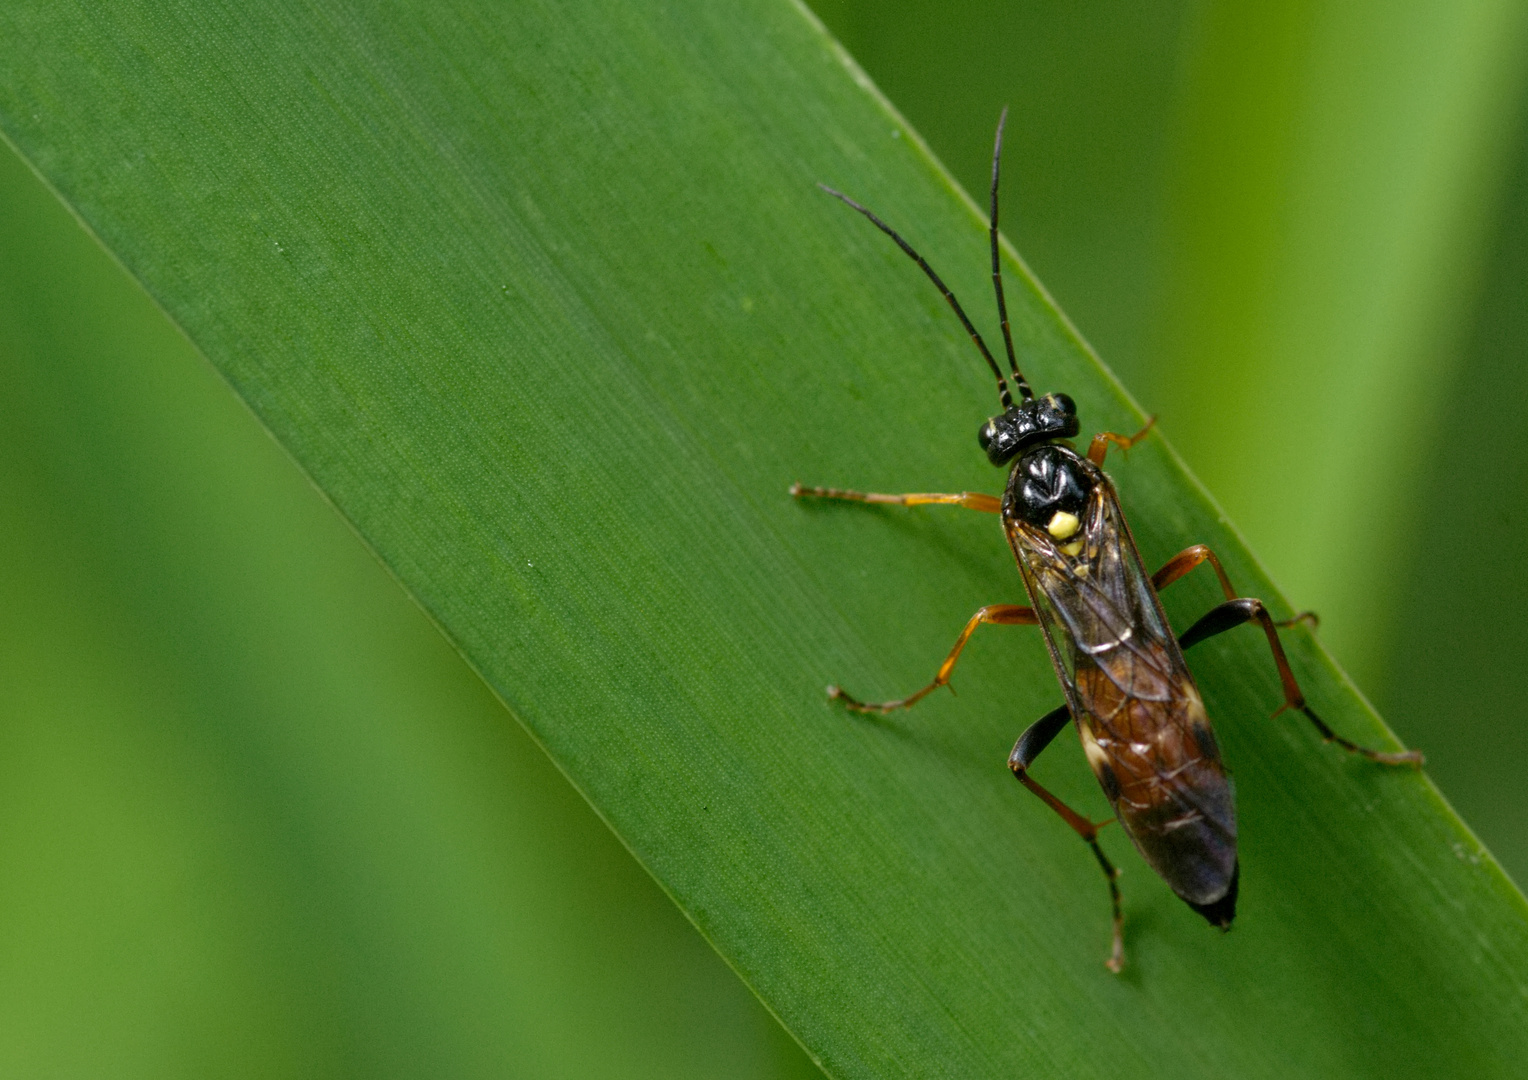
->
[1004, 466, 1236, 904]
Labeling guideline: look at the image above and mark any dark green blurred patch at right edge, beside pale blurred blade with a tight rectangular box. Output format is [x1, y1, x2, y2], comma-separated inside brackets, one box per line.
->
[1377, 125, 1528, 898]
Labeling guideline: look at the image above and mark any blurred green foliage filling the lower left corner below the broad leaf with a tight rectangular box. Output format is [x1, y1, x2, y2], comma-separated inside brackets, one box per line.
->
[0, 130, 816, 1080]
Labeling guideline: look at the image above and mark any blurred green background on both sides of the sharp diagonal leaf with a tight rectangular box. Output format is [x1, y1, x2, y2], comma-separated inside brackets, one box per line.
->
[0, 0, 1528, 1077]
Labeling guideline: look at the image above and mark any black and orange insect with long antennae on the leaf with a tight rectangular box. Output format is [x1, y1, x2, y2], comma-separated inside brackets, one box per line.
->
[790, 110, 1423, 972]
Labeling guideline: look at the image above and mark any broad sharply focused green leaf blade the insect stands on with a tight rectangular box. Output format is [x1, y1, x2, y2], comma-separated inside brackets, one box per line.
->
[0, 3, 1528, 1077]
